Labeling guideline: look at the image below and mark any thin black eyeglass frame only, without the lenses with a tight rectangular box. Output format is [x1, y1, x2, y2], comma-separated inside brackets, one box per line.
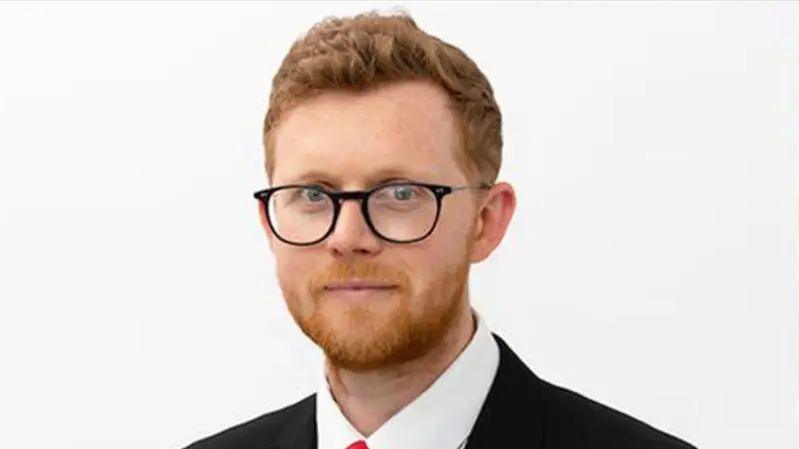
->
[253, 181, 491, 246]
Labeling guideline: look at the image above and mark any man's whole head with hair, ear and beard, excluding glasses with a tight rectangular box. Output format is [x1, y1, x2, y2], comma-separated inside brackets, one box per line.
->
[259, 14, 515, 370]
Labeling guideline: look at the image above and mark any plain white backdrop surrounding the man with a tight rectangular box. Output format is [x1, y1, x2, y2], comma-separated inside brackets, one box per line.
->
[0, 2, 799, 449]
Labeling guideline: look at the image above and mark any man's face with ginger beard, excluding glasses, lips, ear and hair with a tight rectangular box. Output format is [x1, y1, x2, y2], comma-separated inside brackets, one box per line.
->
[259, 81, 477, 370]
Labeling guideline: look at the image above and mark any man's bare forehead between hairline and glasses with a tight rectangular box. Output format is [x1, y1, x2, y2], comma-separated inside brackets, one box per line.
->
[273, 81, 462, 185]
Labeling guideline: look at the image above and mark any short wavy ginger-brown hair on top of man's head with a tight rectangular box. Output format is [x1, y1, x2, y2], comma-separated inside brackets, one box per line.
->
[263, 11, 502, 184]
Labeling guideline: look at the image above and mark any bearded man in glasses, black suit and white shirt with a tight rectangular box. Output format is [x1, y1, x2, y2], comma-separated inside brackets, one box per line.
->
[184, 13, 693, 449]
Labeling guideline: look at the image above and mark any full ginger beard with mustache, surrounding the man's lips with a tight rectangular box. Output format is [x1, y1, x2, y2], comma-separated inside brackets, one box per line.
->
[281, 243, 471, 371]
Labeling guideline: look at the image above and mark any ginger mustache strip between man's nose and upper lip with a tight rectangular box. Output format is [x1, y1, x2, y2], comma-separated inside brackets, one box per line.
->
[309, 260, 410, 294]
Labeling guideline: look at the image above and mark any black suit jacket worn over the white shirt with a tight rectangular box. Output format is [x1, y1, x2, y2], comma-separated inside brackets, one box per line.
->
[186, 332, 696, 449]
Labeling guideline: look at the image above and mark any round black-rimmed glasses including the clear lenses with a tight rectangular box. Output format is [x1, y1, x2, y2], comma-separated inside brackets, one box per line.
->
[253, 182, 491, 246]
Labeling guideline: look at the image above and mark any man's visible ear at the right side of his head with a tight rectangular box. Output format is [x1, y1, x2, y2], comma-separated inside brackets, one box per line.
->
[471, 182, 516, 263]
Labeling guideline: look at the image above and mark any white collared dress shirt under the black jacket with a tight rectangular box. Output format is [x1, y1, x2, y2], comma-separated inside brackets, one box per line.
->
[316, 308, 499, 449]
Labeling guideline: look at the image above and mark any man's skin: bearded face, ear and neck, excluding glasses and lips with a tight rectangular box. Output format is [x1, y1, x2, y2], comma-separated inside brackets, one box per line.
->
[258, 80, 516, 436]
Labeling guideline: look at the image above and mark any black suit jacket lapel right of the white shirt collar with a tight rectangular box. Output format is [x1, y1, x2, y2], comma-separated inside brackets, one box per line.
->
[466, 332, 542, 449]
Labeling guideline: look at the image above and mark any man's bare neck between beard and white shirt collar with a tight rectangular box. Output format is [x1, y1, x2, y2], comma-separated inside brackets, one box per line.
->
[325, 299, 477, 437]
